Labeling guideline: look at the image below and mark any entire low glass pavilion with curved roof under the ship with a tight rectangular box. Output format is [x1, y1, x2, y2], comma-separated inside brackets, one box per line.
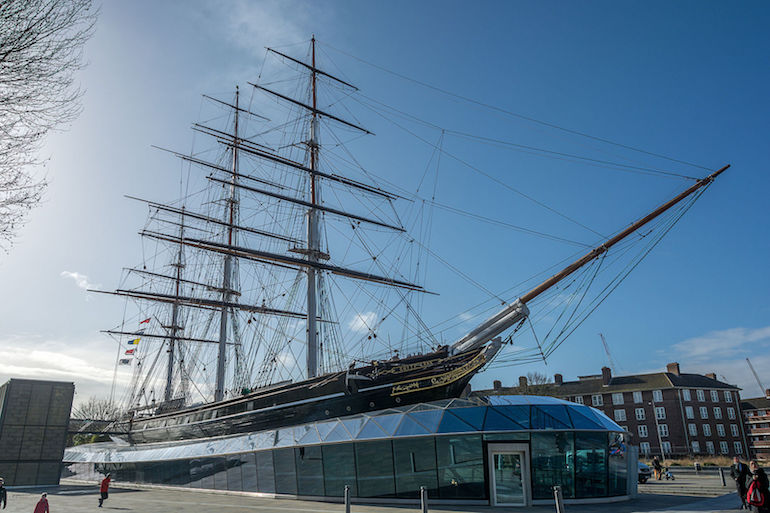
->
[62, 396, 636, 506]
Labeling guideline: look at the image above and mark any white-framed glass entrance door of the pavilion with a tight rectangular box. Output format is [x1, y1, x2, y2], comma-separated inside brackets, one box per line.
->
[489, 444, 529, 506]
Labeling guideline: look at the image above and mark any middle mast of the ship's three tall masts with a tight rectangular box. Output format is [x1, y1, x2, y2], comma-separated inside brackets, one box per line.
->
[214, 86, 240, 401]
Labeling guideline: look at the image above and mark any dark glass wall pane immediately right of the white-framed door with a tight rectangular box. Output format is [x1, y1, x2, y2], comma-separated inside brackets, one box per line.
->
[531, 433, 575, 499]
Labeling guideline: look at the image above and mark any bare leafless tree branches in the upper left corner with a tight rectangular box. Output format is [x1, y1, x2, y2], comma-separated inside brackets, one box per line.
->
[0, 0, 98, 251]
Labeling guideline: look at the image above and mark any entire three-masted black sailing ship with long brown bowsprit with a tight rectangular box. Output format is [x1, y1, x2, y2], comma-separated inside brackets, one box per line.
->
[100, 38, 729, 443]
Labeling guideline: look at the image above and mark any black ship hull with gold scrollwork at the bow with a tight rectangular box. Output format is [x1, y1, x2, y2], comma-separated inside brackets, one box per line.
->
[118, 345, 492, 443]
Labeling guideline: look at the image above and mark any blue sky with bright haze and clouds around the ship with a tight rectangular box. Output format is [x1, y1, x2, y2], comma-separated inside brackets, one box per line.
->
[0, 1, 770, 397]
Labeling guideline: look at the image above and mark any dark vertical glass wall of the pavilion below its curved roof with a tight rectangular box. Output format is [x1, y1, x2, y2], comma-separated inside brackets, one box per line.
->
[67, 430, 633, 500]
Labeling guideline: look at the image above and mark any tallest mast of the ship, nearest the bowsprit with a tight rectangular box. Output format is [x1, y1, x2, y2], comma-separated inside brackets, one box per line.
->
[307, 35, 320, 378]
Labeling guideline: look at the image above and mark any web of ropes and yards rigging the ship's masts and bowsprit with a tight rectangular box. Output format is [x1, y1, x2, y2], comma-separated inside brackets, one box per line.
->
[99, 39, 724, 411]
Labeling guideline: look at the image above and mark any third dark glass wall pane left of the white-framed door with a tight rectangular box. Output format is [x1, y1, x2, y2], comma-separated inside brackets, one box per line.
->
[355, 440, 396, 497]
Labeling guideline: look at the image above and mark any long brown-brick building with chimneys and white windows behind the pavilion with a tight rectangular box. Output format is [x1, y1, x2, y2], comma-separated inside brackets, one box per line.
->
[474, 363, 748, 456]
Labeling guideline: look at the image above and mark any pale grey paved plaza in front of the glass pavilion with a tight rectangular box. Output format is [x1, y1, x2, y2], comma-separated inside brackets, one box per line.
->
[2, 478, 737, 513]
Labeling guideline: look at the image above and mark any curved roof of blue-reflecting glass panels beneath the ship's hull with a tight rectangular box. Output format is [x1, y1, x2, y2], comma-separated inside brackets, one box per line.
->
[64, 395, 624, 463]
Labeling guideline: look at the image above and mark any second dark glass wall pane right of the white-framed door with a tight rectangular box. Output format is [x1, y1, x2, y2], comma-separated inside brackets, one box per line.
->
[575, 432, 607, 498]
